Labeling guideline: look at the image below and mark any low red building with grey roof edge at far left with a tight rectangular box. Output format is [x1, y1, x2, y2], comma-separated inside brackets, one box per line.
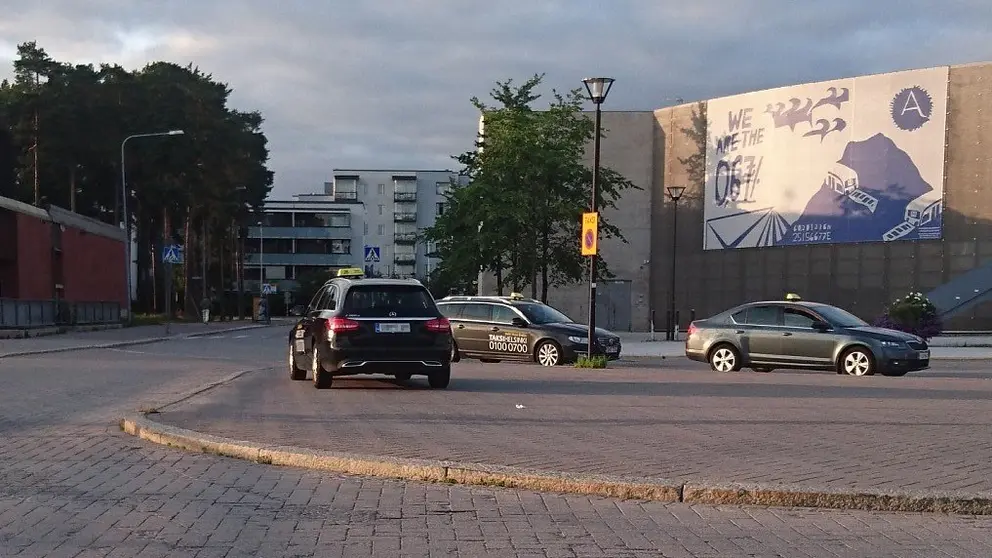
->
[0, 197, 127, 328]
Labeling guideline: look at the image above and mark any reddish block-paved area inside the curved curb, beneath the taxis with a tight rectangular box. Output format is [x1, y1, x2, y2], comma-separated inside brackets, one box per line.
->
[154, 346, 992, 497]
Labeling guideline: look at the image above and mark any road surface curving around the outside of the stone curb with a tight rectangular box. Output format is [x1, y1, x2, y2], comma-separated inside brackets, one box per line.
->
[0, 329, 992, 558]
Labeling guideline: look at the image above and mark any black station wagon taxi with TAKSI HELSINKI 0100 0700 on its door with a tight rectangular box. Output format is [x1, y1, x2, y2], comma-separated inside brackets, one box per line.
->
[437, 293, 621, 366]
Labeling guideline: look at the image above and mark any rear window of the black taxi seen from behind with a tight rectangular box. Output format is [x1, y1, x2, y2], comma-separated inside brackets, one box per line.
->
[343, 285, 437, 318]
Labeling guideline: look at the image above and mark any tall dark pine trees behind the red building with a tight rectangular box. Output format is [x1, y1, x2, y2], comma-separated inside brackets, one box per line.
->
[0, 42, 273, 313]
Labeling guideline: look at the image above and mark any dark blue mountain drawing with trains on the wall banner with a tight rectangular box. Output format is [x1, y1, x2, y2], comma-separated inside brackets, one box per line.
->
[776, 133, 940, 245]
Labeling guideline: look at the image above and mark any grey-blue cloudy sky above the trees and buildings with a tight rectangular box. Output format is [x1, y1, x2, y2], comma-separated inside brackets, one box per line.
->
[0, 0, 992, 198]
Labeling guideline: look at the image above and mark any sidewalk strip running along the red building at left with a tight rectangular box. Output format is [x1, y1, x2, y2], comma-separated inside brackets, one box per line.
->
[0, 318, 284, 358]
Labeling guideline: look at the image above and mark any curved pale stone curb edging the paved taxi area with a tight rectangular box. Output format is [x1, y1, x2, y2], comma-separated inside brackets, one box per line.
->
[120, 416, 992, 515]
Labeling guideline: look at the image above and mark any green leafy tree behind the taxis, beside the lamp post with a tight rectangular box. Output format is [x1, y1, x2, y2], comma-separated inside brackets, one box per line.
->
[424, 74, 639, 302]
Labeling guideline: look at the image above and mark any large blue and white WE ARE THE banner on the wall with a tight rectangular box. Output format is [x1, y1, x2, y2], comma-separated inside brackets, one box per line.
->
[703, 66, 949, 250]
